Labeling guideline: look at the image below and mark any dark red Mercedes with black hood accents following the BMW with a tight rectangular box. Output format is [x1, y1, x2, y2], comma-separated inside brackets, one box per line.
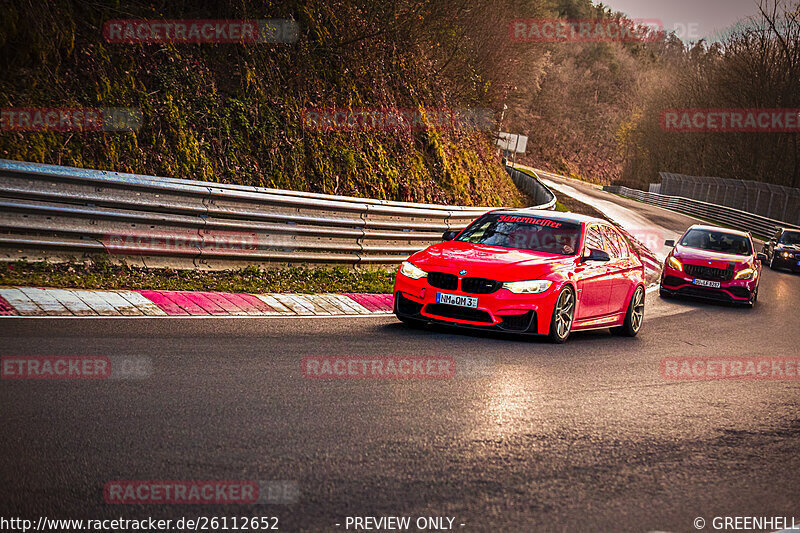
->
[660, 224, 766, 307]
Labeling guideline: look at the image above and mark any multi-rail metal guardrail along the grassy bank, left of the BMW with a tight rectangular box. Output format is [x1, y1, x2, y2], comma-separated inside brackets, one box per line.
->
[0, 160, 555, 270]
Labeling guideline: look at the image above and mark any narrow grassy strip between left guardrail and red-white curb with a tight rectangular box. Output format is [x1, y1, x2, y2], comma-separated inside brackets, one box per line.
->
[0, 261, 394, 294]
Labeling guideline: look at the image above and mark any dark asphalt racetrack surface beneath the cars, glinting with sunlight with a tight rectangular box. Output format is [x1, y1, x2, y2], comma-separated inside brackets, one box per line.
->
[0, 185, 800, 532]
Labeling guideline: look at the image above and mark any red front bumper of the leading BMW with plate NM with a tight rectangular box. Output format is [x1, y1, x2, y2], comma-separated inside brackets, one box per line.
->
[394, 273, 560, 335]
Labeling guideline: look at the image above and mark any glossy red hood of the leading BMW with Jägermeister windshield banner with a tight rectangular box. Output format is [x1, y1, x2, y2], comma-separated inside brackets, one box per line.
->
[409, 241, 575, 281]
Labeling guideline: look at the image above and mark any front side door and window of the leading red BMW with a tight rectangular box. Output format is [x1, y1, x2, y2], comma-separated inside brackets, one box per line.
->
[575, 224, 611, 320]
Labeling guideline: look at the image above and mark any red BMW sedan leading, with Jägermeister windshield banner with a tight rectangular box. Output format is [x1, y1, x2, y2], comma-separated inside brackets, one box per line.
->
[394, 209, 645, 343]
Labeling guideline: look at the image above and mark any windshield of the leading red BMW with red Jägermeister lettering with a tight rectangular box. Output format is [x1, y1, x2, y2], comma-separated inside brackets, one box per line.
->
[456, 215, 581, 255]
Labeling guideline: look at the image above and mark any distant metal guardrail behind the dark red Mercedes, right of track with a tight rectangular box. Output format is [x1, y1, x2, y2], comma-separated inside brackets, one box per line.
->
[603, 185, 800, 237]
